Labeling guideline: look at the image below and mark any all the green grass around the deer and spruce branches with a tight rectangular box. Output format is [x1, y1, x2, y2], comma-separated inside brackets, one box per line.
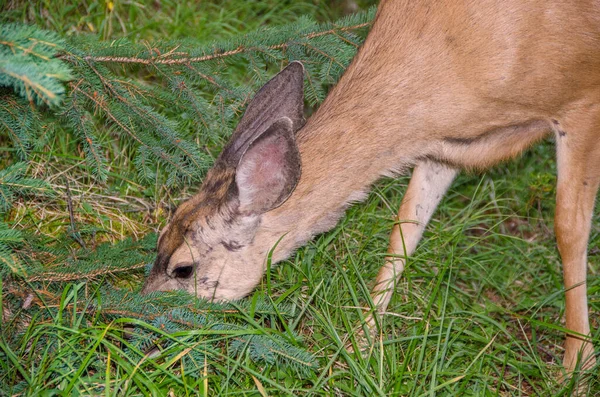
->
[0, 1, 600, 396]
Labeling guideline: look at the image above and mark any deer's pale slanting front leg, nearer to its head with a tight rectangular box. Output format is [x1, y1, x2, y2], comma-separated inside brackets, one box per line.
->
[367, 160, 458, 318]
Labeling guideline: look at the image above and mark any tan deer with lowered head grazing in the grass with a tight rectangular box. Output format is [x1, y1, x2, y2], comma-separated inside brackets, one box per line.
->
[142, 0, 600, 373]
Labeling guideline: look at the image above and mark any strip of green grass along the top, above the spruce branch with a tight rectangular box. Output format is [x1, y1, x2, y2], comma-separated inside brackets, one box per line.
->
[2, 0, 360, 41]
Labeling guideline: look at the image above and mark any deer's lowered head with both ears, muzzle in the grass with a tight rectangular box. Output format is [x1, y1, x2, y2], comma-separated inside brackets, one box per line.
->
[142, 62, 304, 300]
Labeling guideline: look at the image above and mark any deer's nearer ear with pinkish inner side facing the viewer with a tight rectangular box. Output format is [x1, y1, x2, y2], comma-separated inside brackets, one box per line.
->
[235, 118, 301, 214]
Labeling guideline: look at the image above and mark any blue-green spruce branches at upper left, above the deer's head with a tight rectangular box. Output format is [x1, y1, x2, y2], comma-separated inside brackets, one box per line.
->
[0, 10, 373, 186]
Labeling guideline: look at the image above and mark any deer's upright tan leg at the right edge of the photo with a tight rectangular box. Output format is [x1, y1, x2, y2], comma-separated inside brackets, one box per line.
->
[554, 109, 600, 372]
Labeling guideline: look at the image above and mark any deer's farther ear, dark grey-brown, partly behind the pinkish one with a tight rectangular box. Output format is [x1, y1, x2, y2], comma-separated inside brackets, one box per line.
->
[220, 62, 304, 163]
